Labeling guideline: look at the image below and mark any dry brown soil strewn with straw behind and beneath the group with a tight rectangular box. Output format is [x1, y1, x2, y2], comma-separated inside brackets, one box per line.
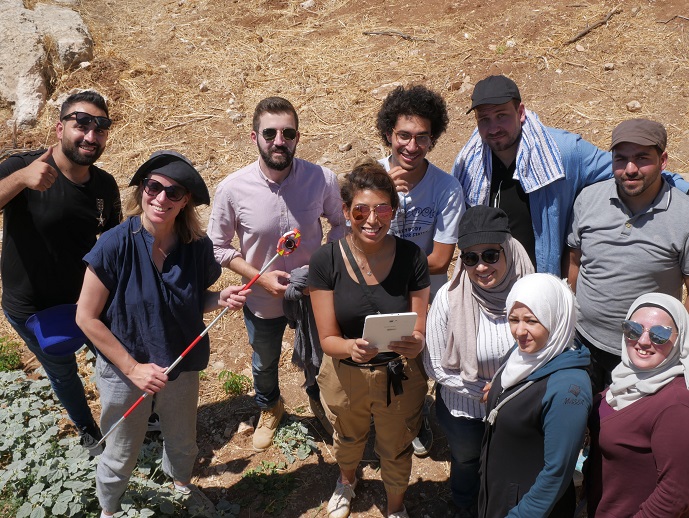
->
[0, 0, 689, 517]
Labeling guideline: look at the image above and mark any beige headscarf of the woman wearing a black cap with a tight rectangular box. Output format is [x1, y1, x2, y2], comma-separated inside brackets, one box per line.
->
[440, 234, 534, 382]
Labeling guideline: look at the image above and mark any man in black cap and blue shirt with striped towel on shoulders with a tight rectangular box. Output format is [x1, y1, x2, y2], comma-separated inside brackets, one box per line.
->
[452, 75, 689, 275]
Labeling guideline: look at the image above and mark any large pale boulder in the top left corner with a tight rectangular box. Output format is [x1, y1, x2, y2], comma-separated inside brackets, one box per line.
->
[0, 0, 93, 128]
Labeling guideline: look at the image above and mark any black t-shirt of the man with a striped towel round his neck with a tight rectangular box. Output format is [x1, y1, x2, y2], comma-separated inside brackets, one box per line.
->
[490, 153, 536, 265]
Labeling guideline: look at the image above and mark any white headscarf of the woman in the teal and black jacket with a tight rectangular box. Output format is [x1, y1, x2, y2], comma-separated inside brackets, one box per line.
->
[501, 273, 577, 389]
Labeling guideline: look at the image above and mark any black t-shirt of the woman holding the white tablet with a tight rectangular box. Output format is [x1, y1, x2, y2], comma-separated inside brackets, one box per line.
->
[309, 237, 431, 338]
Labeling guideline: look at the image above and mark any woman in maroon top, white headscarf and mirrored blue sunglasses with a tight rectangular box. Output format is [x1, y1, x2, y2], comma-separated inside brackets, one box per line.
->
[586, 293, 689, 517]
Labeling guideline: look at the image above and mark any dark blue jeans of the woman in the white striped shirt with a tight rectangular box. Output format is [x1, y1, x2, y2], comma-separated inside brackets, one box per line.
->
[435, 387, 485, 508]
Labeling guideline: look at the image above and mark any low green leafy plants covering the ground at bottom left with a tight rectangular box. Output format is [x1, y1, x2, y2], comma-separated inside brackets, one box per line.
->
[0, 371, 239, 518]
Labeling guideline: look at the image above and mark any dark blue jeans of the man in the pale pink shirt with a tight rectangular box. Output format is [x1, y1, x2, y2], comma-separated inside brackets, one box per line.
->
[244, 306, 287, 410]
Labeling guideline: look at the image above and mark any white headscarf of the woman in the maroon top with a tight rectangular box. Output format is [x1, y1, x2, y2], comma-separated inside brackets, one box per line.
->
[605, 293, 689, 410]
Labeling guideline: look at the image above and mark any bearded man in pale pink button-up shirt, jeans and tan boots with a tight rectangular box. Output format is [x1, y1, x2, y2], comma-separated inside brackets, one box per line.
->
[208, 97, 344, 451]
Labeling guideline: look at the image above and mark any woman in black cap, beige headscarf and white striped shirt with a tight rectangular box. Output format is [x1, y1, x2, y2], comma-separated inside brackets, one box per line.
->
[423, 205, 533, 517]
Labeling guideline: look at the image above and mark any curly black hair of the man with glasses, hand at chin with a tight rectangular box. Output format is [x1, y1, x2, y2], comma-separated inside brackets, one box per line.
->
[376, 85, 450, 149]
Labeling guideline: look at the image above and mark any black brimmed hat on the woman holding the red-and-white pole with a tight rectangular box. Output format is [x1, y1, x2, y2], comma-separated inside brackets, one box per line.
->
[129, 149, 211, 205]
